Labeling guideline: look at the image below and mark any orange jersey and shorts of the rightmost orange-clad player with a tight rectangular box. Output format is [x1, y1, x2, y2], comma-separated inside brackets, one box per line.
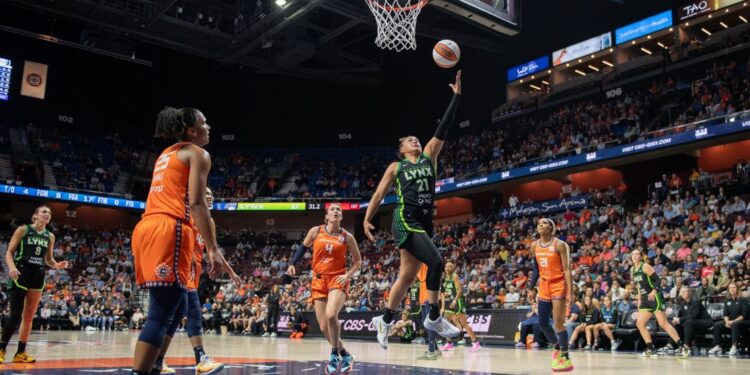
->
[534, 238, 566, 302]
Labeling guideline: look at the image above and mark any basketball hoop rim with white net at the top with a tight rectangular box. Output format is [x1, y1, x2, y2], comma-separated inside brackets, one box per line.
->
[365, 0, 429, 52]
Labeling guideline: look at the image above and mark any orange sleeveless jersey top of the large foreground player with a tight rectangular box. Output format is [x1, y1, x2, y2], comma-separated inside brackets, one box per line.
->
[142, 143, 190, 222]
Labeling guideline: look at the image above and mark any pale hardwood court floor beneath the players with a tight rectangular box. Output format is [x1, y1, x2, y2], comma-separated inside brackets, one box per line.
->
[0, 331, 750, 375]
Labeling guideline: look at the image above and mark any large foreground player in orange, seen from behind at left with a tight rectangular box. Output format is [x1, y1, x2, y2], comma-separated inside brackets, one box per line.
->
[132, 107, 234, 375]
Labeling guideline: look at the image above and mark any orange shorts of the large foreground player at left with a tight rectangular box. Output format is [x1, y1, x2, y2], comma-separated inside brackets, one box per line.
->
[131, 215, 195, 288]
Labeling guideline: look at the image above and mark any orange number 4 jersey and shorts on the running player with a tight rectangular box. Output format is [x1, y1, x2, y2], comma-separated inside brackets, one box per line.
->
[312, 225, 349, 300]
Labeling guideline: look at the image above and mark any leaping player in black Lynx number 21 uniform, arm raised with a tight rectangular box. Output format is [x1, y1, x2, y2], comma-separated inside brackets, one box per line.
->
[364, 70, 461, 349]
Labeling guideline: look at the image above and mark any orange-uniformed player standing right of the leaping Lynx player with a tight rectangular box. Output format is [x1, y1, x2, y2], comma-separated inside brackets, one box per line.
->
[528, 218, 573, 372]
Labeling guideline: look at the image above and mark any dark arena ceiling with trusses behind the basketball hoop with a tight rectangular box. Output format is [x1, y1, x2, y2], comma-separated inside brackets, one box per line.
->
[0, 0, 679, 86]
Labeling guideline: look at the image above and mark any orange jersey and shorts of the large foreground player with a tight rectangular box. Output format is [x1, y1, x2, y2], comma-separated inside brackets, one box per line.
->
[133, 142, 197, 288]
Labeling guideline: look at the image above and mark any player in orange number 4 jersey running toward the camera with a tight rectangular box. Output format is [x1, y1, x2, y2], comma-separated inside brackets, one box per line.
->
[288, 203, 362, 374]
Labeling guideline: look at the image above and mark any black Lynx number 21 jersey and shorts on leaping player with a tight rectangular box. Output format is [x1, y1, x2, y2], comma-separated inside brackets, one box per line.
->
[392, 154, 436, 246]
